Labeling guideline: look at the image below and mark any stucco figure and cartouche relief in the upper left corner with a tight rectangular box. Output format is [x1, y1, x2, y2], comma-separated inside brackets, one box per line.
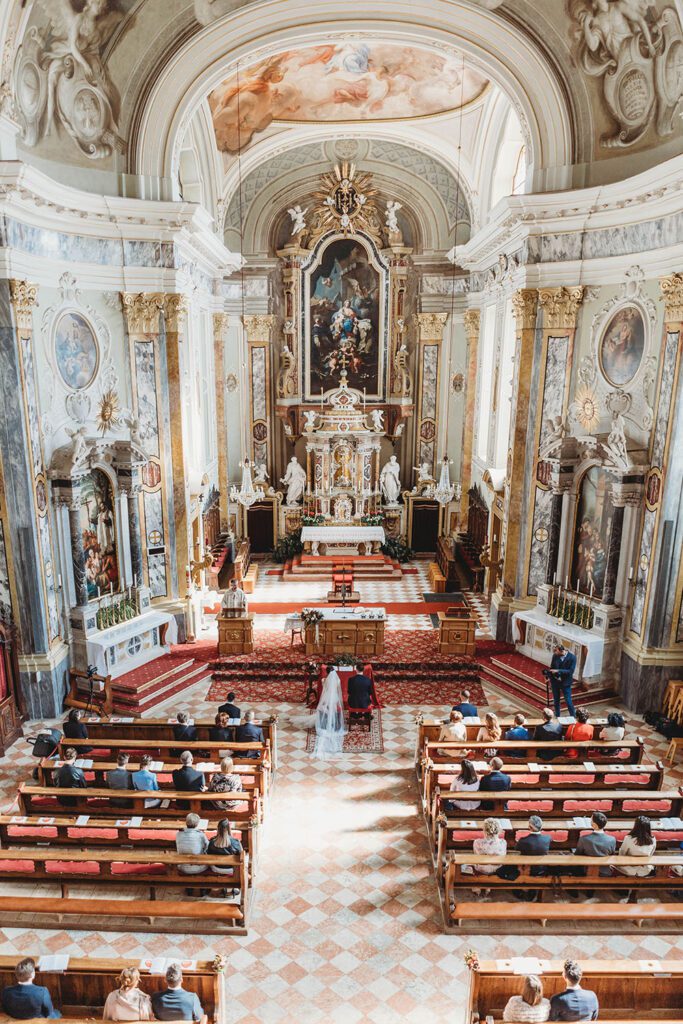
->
[14, 0, 124, 160]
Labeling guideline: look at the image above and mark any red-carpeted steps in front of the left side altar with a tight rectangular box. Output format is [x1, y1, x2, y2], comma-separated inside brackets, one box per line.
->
[112, 651, 211, 716]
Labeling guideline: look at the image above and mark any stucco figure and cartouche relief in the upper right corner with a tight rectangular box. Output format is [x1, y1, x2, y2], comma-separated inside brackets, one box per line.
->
[570, 0, 683, 148]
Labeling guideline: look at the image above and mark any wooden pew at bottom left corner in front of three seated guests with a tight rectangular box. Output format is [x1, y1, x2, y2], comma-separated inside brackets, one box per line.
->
[0, 949, 227, 1024]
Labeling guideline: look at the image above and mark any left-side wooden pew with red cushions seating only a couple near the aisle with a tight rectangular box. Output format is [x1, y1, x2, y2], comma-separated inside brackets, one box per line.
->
[0, 848, 248, 924]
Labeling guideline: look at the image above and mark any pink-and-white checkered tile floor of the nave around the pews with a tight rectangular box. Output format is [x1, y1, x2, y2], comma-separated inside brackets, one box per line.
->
[0, 671, 683, 1024]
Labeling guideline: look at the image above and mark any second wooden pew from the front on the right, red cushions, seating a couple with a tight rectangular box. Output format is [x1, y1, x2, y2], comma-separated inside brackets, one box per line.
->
[422, 761, 665, 836]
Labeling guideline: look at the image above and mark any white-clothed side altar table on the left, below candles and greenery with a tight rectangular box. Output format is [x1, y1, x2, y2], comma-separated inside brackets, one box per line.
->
[87, 611, 178, 679]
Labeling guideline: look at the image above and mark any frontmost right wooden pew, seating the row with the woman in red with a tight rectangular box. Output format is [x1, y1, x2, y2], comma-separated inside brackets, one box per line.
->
[423, 736, 645, 765]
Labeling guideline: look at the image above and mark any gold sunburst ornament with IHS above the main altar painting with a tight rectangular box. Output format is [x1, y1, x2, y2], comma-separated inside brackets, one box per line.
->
[312, 162, 382, 238]
